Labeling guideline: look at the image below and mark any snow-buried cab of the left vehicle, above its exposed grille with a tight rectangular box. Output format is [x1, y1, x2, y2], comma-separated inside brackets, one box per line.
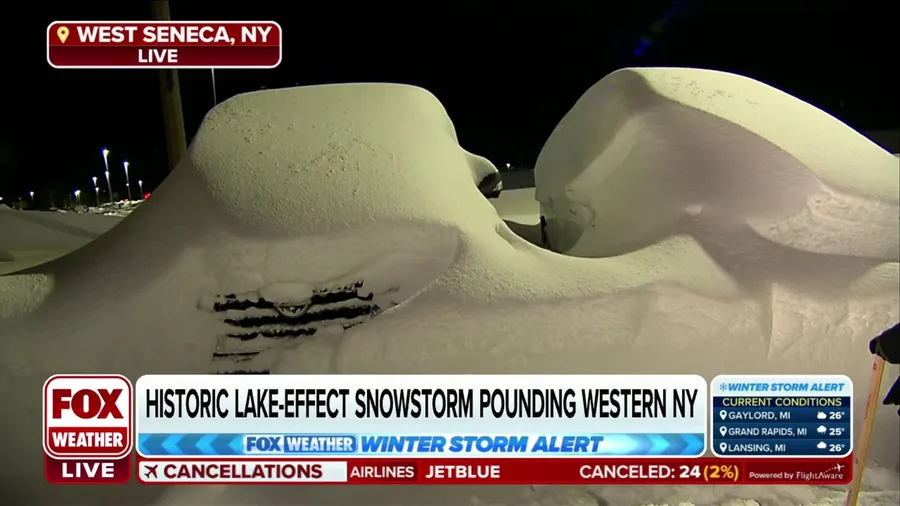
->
[192, 84, 497, 235]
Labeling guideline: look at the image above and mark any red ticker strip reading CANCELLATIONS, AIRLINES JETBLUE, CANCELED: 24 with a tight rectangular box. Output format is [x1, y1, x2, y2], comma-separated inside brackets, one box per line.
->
[136, 457, 852, 485]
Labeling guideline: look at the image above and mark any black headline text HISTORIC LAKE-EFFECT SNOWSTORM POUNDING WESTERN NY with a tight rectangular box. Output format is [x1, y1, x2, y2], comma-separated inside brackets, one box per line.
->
[139, 388, 705, 419]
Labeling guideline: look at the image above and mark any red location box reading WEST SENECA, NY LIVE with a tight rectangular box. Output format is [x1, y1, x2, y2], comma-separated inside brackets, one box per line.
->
[47, 21, 282, 69]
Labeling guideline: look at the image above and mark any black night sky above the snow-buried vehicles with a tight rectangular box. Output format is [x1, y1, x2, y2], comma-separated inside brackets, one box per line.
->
[0, 0, 900, 204]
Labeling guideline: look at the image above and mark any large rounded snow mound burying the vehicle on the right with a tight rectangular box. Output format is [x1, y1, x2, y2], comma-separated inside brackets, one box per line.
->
[535, 68, 900, 262]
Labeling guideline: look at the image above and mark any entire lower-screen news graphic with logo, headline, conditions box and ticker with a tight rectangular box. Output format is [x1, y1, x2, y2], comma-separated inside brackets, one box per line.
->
[43, 375, 852, 485]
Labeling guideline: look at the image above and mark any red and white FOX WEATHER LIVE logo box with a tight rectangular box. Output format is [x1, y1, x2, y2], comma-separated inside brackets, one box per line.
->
[42, 374, 134, 485]
